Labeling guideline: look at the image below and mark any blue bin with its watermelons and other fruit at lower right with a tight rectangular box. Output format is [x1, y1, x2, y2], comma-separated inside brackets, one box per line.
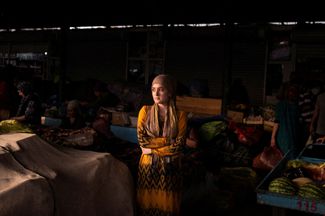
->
[256, 144, 325, 215]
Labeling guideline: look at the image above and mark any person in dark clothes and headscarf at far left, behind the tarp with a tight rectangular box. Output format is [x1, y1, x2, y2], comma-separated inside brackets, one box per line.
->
[11, 81, 42, 125]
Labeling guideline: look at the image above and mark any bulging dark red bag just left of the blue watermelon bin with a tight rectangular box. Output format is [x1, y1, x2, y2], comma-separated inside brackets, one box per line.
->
[253, 146, 283, 170]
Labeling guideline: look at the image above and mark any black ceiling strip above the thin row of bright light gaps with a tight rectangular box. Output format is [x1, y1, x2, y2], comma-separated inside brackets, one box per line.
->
[0, 0, 325, 28]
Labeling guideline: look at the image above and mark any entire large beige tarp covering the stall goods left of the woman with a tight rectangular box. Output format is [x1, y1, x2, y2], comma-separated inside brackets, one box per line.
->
[0, 133, 135, 216]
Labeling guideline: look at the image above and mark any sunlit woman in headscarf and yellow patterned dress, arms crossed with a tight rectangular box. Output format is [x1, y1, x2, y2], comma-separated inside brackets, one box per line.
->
[137, 74, 187, 215]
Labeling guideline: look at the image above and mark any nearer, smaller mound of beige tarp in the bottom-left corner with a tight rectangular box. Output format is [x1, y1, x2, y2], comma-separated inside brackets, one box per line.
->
[0, 146, 54, 216]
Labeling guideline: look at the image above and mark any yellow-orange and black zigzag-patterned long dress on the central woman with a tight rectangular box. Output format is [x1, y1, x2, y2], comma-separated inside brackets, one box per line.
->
[137, 106, 187, 216]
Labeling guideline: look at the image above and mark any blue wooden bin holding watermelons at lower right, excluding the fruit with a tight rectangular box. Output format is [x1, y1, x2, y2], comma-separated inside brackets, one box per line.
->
[256, 144, 325, 215]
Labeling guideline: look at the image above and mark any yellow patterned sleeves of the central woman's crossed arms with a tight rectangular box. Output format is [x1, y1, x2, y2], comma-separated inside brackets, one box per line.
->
[137, 106, 187, 155]
